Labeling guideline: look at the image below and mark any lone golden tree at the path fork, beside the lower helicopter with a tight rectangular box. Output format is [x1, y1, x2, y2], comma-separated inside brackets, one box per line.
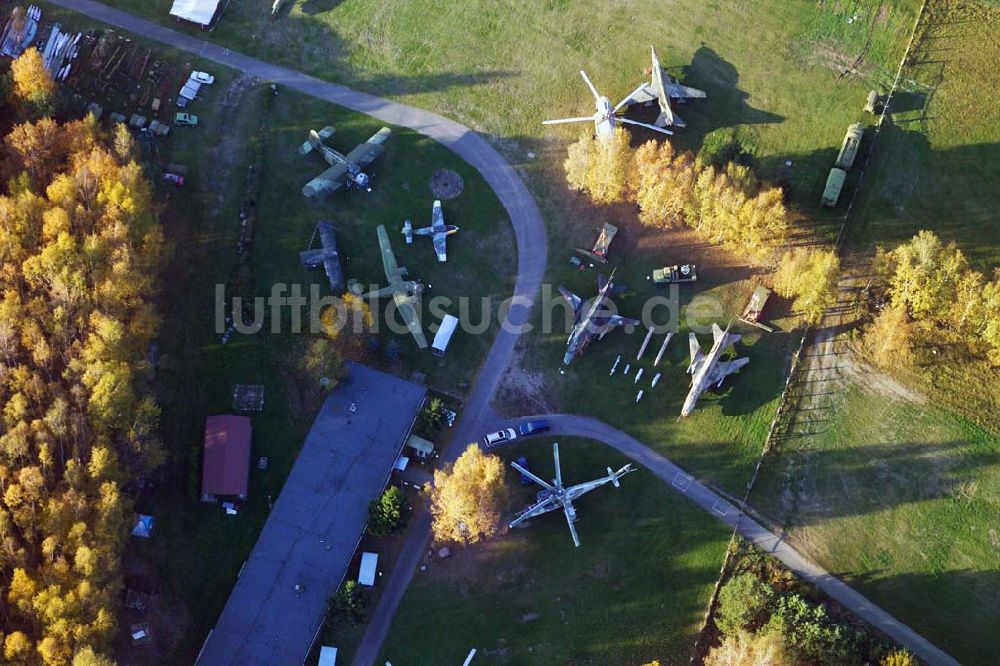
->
[428, 443, 507, 543]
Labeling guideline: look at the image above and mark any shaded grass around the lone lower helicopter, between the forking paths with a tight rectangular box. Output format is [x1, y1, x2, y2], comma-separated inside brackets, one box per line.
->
[379, 439, 729, 664]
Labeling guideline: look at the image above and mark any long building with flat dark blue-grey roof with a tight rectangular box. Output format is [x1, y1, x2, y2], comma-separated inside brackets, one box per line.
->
[197, 363, 426, 666]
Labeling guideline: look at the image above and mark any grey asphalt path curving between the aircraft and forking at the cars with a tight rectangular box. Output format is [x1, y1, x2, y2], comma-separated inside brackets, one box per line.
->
[49, 0, 958, 666]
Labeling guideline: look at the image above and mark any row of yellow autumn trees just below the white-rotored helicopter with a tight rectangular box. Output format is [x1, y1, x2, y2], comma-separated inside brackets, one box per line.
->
[563, 127, 789, 260]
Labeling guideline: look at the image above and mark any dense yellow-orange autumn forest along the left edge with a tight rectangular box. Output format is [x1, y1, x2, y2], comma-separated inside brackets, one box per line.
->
[0, 116, 164, 666]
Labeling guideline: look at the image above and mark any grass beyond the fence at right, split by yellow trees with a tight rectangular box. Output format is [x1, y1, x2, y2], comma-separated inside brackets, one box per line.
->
[750, 2, 1000, 664]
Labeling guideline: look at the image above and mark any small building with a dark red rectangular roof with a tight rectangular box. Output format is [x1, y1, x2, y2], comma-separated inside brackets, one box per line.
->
[201, 414, 251, 502]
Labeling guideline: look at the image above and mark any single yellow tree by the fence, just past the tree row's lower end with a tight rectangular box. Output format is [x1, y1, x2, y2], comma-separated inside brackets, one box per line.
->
[774, 248, 840, 324]
